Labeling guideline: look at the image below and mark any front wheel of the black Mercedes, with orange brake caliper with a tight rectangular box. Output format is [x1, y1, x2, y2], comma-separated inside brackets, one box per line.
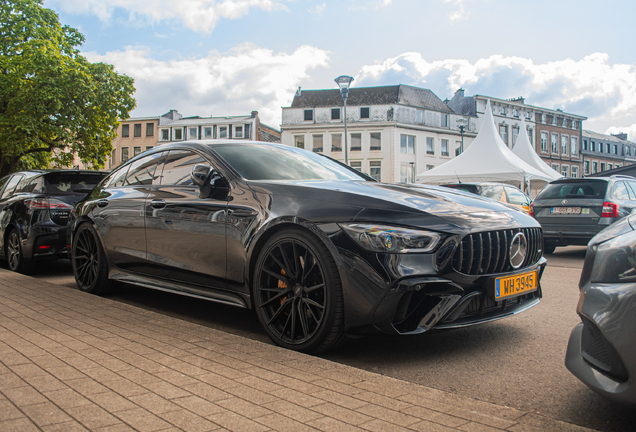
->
[253, 228, 344, 354]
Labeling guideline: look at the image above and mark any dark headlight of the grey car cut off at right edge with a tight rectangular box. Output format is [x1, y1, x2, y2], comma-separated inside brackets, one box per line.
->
[590, 231, 636, 283]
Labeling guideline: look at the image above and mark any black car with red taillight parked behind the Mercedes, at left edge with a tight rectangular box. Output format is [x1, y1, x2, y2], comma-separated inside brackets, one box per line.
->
[0, 170, 107, 273]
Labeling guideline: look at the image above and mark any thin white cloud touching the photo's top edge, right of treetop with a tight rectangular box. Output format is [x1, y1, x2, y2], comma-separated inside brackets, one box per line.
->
[46, 0, 287, 33]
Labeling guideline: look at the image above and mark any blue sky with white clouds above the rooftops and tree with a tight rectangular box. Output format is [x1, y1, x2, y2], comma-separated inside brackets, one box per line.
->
[44, 0, 636, 140]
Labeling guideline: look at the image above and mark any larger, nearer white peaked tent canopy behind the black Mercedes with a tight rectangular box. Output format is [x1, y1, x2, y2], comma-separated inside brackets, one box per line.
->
[416, 101, 553, 184]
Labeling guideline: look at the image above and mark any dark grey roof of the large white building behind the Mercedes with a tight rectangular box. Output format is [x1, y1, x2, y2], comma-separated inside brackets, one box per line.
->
[291, 84, 453, 113]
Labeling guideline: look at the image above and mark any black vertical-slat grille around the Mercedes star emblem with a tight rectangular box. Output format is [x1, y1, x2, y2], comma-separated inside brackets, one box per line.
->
[453, 228, 543, 275]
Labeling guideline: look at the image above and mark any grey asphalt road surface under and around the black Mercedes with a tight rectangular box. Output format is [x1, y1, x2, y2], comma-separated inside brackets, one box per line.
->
[24, 247, 636, 431]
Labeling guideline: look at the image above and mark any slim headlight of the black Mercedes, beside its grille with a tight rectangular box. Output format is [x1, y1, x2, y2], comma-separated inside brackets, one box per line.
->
[340, 223, 442, 253]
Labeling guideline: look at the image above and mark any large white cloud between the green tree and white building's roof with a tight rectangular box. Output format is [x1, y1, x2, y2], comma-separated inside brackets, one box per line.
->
[84, 45, 330, 127]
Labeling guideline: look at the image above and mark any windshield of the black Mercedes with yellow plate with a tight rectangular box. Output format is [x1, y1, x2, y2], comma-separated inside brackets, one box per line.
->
[214, 144, 372, 181]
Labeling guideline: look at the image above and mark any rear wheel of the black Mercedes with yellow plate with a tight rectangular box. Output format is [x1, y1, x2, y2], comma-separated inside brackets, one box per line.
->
[71, 223, 116, 295]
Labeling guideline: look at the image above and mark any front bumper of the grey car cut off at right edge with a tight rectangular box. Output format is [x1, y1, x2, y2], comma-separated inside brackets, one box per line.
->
[565, 283, 636, 404]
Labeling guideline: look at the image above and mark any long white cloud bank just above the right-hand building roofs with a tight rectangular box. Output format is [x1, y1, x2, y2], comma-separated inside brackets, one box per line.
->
[355, 52, 636, 126]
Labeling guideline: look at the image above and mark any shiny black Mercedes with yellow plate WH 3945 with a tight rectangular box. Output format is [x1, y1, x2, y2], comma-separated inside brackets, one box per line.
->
[72, 141, 545, 352]
